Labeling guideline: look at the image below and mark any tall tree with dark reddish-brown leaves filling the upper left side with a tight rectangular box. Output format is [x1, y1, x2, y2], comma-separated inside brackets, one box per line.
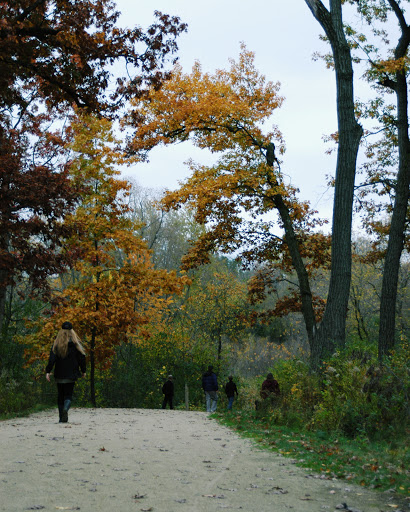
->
[0, 0, 185, 332]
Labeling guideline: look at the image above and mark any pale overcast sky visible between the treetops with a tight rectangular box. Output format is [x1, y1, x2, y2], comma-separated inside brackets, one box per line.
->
[116, 0, 388, 222]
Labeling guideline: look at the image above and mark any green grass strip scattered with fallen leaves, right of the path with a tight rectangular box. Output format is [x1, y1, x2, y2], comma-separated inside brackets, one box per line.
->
[214, 411, 410, 498]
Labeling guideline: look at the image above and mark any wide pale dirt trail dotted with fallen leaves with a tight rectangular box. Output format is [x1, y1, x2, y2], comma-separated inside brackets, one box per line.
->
[0, 408, 394, 512]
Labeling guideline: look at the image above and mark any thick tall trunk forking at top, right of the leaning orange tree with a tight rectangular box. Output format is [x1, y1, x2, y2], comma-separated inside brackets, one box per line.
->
[305, 0, 363, 369]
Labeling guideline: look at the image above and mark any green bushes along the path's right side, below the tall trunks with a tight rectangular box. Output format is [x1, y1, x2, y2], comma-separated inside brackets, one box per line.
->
[248, 342, 410, 439]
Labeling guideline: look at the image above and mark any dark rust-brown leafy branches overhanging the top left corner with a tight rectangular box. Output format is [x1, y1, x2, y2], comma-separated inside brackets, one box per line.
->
[0, 0, 185, 111]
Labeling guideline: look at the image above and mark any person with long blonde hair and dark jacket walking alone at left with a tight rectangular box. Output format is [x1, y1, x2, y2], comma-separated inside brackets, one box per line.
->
[46, 322, 86, 423]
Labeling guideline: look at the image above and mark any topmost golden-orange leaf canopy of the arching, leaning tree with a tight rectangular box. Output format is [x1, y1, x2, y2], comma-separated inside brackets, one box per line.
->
[126, 45, 283, 158]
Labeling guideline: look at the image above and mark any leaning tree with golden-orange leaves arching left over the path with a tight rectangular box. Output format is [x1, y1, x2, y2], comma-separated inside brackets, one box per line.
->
[128, 47, 330, 368]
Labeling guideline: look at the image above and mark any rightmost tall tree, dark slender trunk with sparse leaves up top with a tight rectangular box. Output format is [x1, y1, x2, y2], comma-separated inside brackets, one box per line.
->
[358, 0, 410, 362]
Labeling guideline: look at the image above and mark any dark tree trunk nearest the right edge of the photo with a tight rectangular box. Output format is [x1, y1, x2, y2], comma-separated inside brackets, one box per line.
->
[379, 28, 410, 362]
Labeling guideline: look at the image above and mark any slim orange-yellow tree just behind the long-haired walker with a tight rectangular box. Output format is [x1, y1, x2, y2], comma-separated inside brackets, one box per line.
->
[24, 117, 186, 405]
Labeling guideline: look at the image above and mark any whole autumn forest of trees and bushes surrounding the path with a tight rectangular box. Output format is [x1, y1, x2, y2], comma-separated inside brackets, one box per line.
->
[0, 0, 410, 485]
